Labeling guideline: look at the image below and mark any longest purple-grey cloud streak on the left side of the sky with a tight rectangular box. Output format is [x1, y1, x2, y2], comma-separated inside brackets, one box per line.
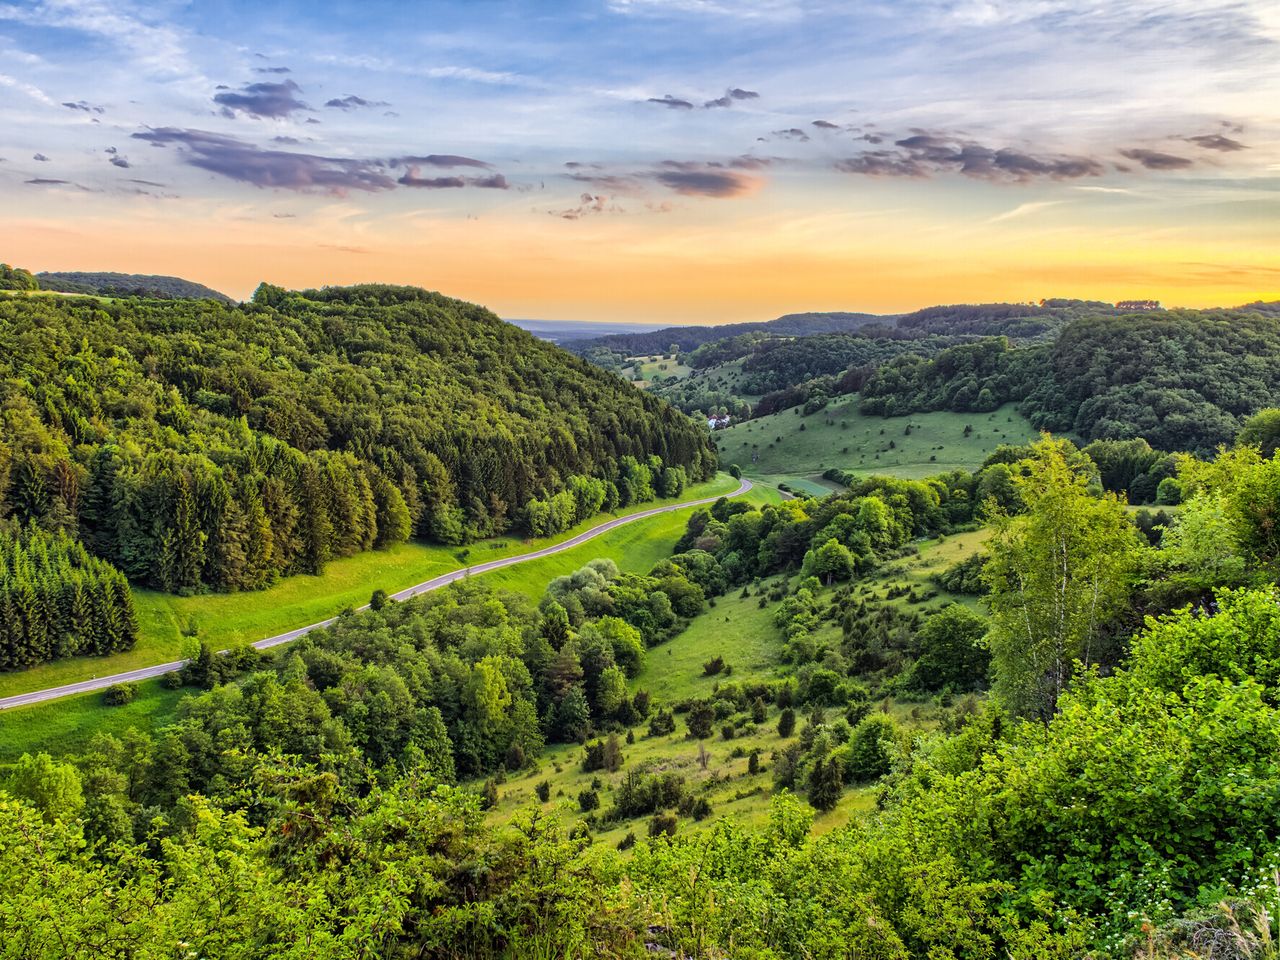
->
[133, 127, 396, 193]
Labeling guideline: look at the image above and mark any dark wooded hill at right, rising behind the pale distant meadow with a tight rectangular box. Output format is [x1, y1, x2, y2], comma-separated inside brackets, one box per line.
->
[860, 308, 1280, 454]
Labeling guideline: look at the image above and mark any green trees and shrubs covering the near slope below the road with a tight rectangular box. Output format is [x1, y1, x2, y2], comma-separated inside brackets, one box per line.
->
[0, 439, 1280, 960]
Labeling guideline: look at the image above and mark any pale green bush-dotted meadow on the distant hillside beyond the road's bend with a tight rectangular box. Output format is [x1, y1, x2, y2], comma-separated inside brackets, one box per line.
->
[716, 397, 1037, 493]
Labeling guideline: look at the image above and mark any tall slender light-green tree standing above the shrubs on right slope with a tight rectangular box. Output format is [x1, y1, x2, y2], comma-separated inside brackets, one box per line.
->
[984, 435, 1139, 719]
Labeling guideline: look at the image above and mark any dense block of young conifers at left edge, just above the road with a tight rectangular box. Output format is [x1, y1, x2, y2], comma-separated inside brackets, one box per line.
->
[0, 527, 138, 669]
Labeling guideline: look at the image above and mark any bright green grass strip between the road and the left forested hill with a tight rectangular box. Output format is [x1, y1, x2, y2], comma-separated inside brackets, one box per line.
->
[0, 474, 737, 696]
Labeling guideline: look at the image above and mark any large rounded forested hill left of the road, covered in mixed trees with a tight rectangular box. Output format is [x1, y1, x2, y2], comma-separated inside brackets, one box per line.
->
[0, 284, 716, 604]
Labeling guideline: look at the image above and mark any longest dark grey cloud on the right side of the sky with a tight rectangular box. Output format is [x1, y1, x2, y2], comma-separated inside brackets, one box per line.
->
[836, 131, 1105, 183]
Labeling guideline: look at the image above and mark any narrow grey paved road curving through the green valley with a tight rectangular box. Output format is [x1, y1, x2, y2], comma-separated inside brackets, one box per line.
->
[0, 479, 754, 710]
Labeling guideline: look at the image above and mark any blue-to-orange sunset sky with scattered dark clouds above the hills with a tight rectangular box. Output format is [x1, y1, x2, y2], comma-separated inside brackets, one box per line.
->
[0, 0, 1280, 323]
